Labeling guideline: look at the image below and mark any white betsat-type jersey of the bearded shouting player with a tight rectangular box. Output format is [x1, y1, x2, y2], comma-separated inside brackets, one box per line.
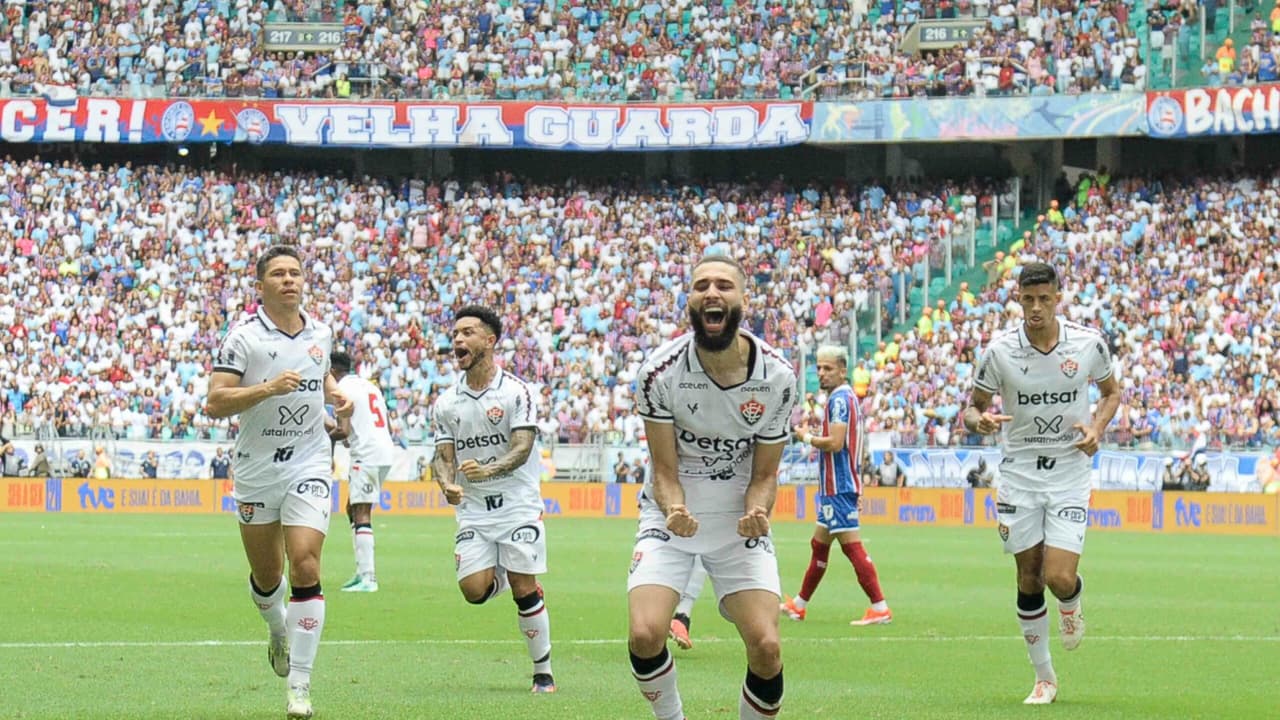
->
[636, 331, 796, 516]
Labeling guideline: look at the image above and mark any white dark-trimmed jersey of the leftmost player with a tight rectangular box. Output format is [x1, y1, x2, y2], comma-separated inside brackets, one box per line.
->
[214, 307, 333, 492]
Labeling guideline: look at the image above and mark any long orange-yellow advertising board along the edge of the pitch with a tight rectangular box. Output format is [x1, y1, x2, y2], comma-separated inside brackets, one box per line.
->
[0, 478, 1280, 536]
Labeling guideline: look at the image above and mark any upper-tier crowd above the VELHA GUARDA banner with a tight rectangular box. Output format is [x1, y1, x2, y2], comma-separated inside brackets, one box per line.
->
[0, 0, 1162, 101]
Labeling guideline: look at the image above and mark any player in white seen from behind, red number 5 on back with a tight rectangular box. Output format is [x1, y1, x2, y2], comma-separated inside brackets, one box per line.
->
[329, 352, 396, 592]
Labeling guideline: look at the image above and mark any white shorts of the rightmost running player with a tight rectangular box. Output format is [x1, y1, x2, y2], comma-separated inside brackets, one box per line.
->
[996, 475, 1091, 555]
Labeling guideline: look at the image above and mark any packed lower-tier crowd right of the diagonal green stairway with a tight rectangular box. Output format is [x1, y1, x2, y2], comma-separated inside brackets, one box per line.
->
[810, 170, 1280, 451]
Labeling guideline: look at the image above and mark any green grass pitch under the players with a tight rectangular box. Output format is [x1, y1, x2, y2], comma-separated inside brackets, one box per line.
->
[0, 515, 1280, 720]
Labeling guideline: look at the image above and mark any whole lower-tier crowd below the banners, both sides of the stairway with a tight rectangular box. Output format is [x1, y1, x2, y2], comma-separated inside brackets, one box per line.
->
[0, 160, 1280, 446]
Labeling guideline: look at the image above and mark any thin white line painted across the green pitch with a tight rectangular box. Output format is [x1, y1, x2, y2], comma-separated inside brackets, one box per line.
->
[0, 635, 1280, 650]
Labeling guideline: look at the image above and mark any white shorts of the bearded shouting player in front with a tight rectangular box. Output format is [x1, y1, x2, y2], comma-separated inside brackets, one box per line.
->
[627, 504, 782, 621]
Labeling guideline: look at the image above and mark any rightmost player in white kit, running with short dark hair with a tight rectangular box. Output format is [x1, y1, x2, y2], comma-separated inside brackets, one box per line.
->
[964, 263, 1120, 705]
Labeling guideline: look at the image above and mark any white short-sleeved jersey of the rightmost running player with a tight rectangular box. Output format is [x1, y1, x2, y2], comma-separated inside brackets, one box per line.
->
[974, 316, 1112, 489]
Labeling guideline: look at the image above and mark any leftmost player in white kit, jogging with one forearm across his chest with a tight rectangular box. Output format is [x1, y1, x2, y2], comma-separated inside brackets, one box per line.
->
[205, 245, 352, 719]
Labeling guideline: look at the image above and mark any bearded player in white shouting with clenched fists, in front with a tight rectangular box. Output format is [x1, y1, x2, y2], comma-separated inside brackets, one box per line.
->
[627, 255, 796, 720]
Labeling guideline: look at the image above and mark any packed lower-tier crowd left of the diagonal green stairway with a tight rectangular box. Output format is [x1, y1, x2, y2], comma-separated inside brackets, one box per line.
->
[0, 156, 984, 443]
